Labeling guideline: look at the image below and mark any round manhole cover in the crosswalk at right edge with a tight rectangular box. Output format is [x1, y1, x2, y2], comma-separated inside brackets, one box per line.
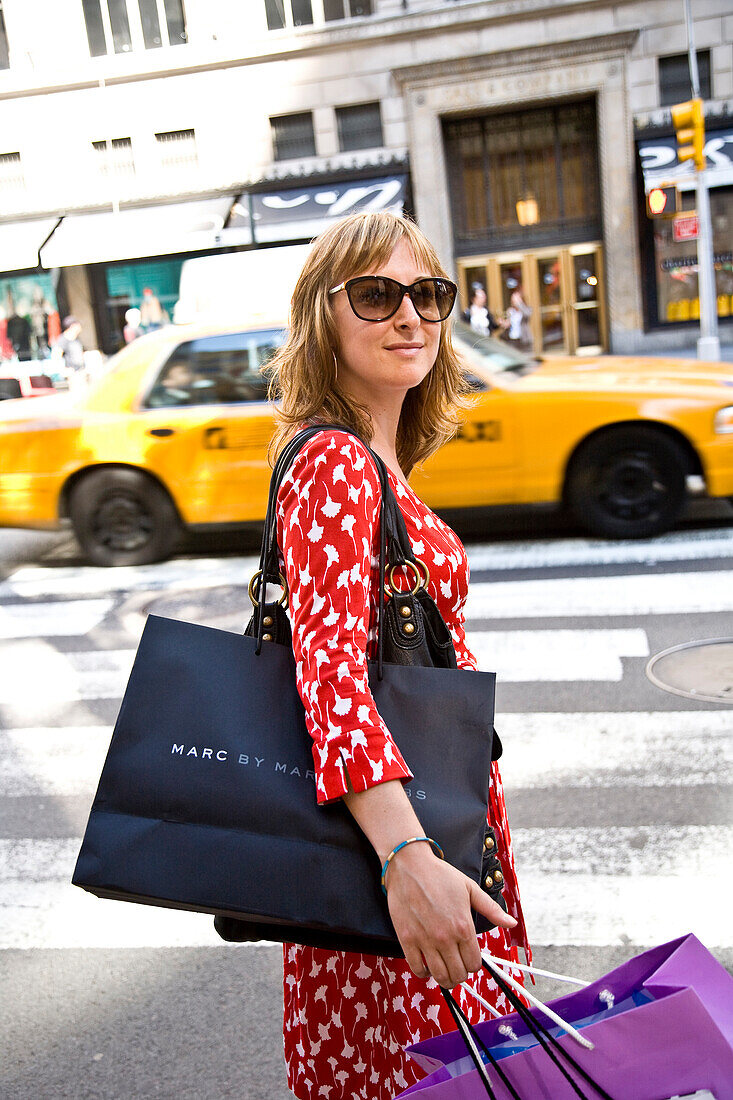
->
[646, 638, 733, 704]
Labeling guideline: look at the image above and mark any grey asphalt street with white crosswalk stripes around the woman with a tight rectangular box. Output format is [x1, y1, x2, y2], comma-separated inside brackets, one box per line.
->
[0, 509, 733, 1100]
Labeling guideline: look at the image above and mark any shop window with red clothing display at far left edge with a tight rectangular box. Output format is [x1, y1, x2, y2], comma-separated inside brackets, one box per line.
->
[0, 273, 61, 362]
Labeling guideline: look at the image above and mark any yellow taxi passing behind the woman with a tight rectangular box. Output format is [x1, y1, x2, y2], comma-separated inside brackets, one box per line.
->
[0, 321, 733, 565]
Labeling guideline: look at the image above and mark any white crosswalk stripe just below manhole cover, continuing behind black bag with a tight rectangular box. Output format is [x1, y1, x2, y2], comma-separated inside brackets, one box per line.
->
[0, 710, 733, 801]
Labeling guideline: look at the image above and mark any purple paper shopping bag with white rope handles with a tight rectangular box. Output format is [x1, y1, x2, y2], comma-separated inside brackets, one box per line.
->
[400, 935, 733, 1100]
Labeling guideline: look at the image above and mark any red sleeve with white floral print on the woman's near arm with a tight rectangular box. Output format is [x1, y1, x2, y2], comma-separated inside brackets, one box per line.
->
[277, 430, 413, 803]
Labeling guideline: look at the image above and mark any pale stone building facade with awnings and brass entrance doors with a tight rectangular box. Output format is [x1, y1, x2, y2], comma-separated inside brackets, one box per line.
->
[0, 0, 733, 354]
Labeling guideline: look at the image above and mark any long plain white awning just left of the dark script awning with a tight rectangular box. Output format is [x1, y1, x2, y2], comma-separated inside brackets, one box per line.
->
[41, 196, 239, 267]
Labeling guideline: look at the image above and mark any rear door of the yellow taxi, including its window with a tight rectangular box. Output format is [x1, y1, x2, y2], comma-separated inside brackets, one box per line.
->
[137, 330, 284, 525]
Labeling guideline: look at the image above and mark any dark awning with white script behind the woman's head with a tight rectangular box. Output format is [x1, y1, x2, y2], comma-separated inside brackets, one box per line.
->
[222, 173, 407, 244]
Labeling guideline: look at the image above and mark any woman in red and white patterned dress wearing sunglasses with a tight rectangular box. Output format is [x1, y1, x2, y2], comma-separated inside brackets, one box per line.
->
[267, 213, 526, 1100]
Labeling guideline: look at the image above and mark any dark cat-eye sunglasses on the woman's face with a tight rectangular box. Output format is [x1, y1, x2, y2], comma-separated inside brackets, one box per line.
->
[328, 275, 458, 321]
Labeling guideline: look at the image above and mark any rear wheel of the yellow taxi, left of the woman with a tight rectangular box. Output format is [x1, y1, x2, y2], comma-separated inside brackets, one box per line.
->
[69, 470, 182, 565]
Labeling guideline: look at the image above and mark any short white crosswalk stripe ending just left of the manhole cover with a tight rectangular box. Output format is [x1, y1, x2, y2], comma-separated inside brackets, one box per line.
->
[467, 629, 649, 683]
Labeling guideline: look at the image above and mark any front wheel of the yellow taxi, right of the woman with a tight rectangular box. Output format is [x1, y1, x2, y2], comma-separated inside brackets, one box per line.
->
[566, 425, 689, 539]
